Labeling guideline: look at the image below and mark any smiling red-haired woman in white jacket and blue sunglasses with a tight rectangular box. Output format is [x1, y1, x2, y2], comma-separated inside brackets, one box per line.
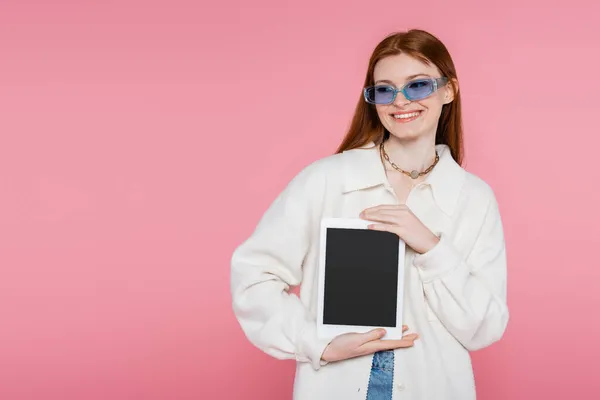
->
[231, 30, 508, 400]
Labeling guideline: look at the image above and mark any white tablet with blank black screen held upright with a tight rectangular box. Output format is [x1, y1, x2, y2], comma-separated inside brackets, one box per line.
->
[317, 218, 405, 339]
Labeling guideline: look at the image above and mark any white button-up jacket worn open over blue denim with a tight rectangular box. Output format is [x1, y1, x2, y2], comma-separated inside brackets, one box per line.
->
[231, 143, 508, 400]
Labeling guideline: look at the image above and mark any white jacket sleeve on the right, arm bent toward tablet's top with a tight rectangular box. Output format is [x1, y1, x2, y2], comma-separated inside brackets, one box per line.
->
[414, 194, 509, 350]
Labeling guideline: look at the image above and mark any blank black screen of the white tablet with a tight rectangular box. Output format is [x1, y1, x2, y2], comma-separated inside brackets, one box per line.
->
[323, 228, 399, 327]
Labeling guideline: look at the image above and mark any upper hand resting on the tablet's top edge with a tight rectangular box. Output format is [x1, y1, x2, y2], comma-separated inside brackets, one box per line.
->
[360, 204, 440, 254]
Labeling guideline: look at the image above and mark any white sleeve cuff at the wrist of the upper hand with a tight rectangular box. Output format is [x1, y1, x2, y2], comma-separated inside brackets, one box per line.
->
[413, 234, 462, 282]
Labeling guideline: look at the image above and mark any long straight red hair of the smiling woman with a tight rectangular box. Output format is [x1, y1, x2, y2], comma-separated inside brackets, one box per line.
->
[336, 29, 463, 165]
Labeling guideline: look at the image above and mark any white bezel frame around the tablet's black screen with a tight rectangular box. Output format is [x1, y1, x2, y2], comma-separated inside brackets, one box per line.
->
[317, 218, 406, 340]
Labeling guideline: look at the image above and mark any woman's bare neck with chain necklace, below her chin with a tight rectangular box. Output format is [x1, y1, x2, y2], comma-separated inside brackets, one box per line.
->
[384, 135, 435, 172]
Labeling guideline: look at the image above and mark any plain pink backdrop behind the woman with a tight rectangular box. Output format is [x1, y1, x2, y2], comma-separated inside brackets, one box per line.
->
[0, 0, 600, 400]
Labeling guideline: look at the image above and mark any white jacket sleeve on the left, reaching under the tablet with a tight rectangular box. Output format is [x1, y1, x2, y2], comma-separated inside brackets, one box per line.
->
[231, 164, 328, 369]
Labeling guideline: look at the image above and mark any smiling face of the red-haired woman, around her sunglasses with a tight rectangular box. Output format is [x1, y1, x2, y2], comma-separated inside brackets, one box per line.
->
[373, 53, 453, 140]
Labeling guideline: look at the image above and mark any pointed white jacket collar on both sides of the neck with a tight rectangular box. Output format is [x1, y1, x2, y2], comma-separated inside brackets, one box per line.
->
[342, 142, 466, 215]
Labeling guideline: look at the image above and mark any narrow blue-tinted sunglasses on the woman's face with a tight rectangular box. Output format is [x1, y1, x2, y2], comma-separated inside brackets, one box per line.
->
[364, 77, 448, 104]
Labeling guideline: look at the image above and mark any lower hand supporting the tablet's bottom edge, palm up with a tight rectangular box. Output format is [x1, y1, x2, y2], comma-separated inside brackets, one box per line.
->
[321, 325, 419, 362]
